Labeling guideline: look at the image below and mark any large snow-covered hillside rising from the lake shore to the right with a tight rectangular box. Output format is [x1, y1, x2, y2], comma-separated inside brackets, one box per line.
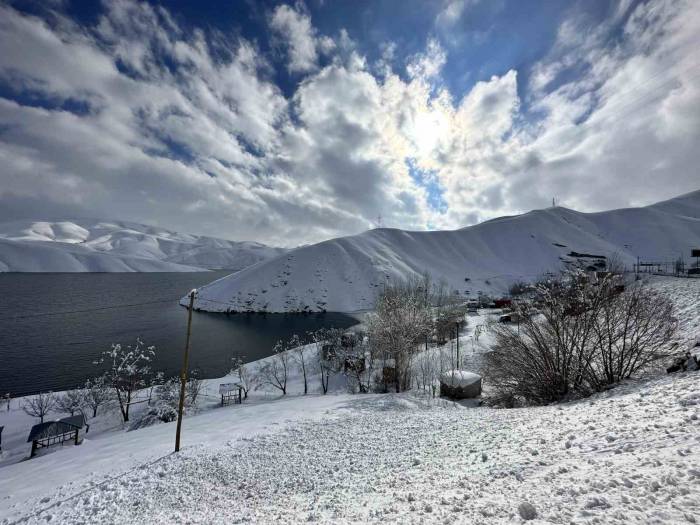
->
[183, 191, 700, 312]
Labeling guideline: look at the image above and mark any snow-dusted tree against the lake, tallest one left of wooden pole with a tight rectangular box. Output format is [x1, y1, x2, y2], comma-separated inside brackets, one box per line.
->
[96, 338, 155, 423]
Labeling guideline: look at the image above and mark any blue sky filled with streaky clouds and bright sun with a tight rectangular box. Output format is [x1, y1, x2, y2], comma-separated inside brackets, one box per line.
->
[0, 0, 700, 247]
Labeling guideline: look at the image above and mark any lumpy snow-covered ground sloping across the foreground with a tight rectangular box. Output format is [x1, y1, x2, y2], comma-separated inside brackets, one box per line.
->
[0, 278, 700, 523]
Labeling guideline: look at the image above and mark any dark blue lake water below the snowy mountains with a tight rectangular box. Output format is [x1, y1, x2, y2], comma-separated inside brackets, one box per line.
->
[0, 272, 357, 396]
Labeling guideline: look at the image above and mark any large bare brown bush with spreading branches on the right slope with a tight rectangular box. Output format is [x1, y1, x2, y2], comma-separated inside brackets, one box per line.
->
[484, 273, 676, 406]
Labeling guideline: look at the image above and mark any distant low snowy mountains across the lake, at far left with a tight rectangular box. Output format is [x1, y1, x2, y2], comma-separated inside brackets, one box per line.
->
[0, 219, 285, 272]
